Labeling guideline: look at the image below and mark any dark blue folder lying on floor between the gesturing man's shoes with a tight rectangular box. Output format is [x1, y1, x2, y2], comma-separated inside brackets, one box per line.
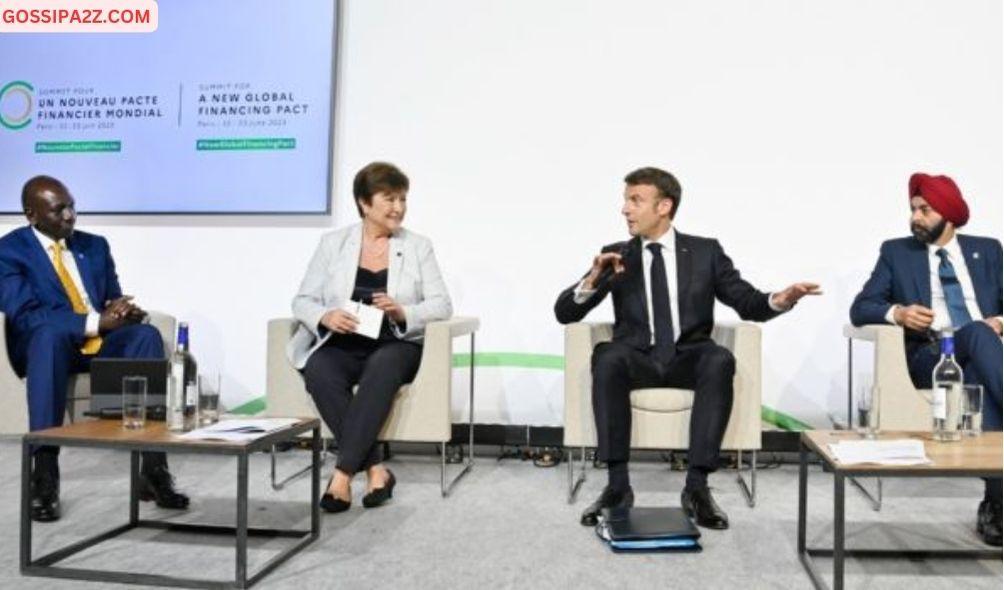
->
[596, 507, 701, 552]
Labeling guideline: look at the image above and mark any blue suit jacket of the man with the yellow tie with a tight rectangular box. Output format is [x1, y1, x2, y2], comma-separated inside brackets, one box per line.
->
[0, 226, 121, 374]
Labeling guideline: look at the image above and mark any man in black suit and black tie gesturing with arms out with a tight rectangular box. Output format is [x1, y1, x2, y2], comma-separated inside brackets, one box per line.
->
[554, 168, 820, 529]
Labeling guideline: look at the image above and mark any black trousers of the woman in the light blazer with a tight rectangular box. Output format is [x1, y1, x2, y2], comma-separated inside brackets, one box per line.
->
[303, 338, 422, 474]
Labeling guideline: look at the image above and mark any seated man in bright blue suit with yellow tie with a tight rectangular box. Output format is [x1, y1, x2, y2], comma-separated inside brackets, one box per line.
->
[0, 176, 189, 522]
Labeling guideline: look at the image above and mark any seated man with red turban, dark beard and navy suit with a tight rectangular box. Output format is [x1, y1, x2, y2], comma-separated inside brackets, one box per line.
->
[850, 173, 1004, 546]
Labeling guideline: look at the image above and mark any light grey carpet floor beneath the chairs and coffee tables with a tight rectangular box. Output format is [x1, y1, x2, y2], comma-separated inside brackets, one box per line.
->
[0, 439, 1002, 590]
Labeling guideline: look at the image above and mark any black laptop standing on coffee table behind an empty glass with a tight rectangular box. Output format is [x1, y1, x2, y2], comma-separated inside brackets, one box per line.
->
[84, 358, 170, 419]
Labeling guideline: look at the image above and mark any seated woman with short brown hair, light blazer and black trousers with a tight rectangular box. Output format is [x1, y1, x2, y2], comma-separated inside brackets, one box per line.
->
[286, 162, 453, 513]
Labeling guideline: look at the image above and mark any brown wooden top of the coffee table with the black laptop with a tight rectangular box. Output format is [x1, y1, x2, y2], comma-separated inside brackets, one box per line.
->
[24, 416, 320, 453]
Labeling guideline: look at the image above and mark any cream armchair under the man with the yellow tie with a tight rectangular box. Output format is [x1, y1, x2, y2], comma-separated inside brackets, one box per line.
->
[0, 311, 176, 434]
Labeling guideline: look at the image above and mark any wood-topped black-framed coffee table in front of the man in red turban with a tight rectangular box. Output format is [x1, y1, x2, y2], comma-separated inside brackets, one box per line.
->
[798, 430, 1002, 590]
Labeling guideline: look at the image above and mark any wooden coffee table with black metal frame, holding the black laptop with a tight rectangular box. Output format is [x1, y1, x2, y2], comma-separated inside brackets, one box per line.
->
[20, 418, 321, 588]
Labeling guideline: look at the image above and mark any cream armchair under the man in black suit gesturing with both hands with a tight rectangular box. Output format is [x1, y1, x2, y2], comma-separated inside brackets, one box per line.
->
[564, 322, 762, 507]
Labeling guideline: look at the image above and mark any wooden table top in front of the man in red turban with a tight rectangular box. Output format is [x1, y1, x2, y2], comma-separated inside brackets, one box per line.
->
[801, 430, 1004, 475]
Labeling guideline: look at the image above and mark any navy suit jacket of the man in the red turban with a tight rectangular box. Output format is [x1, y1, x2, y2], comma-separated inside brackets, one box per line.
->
[850, 235, 1004, 341]
